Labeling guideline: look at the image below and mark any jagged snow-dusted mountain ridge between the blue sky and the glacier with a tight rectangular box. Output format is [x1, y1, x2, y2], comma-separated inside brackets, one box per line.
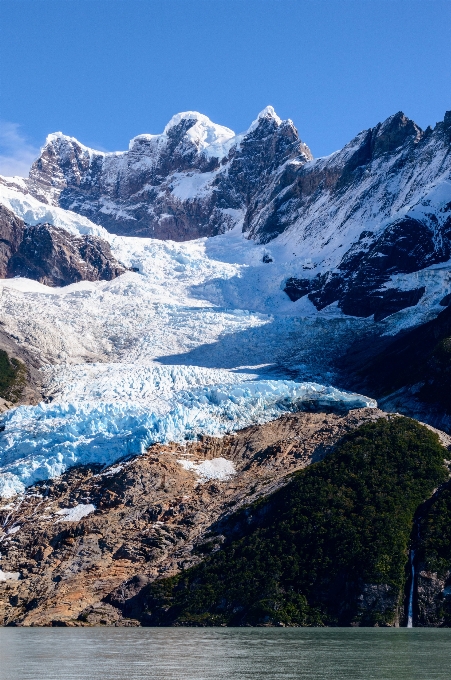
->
[2, 107, 451, 321]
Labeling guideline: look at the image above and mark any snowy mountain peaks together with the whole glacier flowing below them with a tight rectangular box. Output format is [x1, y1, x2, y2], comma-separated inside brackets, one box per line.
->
[0, 107, 451, 494]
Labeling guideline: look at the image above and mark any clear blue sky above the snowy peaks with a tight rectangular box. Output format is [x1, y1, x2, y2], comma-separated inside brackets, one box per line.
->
[0, 0, 451, 174]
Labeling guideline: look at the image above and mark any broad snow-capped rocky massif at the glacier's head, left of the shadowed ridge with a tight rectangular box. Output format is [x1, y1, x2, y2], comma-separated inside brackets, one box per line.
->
[26, 106, 312, 241]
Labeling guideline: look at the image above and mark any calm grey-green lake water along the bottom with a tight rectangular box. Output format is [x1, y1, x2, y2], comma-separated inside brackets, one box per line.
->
[0, 628, 451, 680]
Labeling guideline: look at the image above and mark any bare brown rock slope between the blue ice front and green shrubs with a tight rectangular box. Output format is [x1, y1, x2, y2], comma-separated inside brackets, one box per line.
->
[0, 409, 385, 626]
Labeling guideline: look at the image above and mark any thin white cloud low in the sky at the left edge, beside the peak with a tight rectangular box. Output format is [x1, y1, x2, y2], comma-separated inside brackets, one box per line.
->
[0, 121, 39, 177]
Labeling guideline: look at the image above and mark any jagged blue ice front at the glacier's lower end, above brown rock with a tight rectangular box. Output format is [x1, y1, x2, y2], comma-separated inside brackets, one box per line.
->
[0, 380, 376, 497]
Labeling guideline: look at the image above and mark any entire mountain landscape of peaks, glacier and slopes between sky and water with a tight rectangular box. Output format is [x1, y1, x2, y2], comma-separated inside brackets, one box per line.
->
[0, 107, 451, 626]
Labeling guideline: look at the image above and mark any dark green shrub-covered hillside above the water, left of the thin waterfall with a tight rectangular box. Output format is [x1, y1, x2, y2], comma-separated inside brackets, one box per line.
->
[142, 416, 448, 626]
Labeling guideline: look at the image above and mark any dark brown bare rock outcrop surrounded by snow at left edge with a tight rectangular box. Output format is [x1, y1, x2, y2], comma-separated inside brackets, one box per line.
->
[0, 205, 125, 286]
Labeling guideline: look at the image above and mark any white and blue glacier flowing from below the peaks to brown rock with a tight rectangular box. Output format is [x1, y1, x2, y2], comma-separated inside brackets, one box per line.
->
[0, 187, 375, 496]
